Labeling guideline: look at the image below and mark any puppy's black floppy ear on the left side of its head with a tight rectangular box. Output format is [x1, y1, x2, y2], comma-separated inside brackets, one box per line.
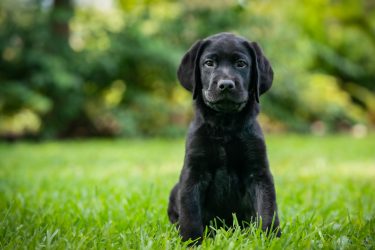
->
[177, 40, 206, 99]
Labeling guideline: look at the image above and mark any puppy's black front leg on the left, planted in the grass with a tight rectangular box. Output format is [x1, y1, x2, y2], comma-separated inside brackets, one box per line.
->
[179, 171, 203, 244]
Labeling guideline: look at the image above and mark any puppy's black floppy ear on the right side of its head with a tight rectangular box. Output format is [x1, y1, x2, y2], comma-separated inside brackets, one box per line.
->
[246, 42, 273, 103]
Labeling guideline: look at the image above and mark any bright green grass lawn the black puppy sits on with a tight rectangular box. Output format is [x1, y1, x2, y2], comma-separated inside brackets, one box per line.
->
[0, 135, 375, 249]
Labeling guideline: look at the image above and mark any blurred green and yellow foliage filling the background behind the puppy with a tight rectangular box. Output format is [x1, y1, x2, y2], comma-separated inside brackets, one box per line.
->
[0, 0, 375, 138]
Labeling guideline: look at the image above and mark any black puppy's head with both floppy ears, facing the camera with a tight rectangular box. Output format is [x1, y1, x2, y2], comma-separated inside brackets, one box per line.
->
[177, 33, 273, 113]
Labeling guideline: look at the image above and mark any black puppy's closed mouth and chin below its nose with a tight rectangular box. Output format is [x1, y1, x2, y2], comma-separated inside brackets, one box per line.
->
[203, 91, 247, 113]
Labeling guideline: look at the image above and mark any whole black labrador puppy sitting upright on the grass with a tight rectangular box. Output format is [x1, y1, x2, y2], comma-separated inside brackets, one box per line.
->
[168, 33, 280, 243]
